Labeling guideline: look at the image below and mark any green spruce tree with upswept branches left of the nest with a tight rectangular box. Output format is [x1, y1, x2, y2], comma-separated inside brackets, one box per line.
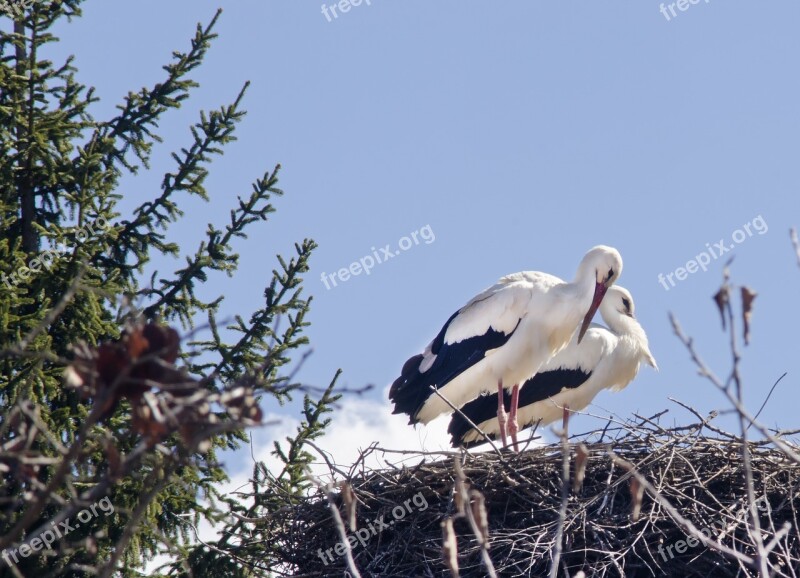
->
[0, 0, 337, 576]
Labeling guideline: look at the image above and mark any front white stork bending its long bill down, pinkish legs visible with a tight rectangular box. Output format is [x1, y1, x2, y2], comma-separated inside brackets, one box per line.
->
[389, 245, 622, 448]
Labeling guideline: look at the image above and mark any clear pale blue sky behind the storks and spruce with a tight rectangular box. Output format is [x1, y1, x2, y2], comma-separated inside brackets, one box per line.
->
[50, 0, 800, 468]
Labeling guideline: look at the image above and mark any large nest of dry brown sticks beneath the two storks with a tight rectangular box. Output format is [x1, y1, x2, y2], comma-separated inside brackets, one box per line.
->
[265, 415, 800, 578]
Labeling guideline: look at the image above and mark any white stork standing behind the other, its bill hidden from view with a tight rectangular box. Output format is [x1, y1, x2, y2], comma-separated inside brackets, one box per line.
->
[447, 286, 658, 447]
